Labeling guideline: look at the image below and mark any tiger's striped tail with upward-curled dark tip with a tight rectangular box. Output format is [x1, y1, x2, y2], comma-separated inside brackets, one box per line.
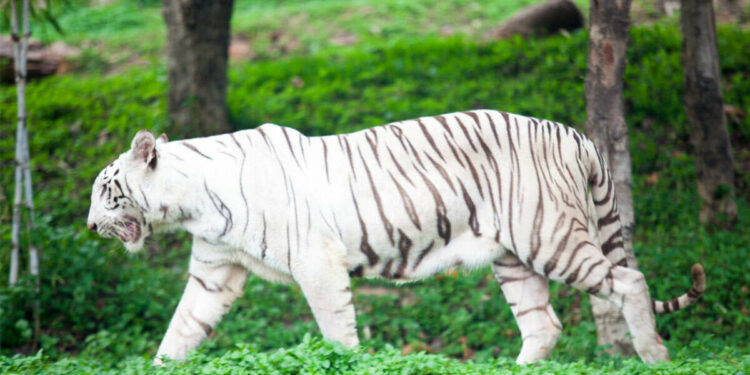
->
[586, 141, 706, 314]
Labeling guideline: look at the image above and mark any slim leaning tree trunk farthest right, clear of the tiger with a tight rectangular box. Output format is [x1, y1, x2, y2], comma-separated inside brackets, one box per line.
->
[681, 0, 737, 223]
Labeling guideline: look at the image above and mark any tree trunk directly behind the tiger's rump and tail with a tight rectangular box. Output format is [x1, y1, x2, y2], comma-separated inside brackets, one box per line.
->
[586, 0, 638, 356]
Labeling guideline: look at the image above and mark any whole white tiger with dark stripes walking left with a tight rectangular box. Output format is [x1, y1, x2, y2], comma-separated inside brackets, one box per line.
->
[88, 110, 705, 363]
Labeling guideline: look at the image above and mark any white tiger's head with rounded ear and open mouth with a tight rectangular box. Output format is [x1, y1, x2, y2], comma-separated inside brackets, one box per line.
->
[87, 130, 167, 252]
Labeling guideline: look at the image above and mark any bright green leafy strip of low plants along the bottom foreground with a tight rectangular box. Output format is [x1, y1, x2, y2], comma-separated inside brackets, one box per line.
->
[0, 336, 750, 375]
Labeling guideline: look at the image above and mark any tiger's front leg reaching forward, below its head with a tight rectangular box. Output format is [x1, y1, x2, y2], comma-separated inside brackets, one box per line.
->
[154, 240, 248, 365]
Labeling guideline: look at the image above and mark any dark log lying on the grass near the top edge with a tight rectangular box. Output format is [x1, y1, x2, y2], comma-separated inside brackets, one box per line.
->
[487, 0, 583, 39]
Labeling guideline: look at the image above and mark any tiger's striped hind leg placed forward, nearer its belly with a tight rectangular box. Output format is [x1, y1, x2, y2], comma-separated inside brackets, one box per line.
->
[492, 253, 562, 364]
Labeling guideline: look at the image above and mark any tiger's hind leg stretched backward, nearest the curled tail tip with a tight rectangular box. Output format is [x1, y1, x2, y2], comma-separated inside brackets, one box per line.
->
[534, 241, 669, 363]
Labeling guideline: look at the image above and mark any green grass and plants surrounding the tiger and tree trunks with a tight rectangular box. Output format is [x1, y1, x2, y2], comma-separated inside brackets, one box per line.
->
[0, 0, 750, 374]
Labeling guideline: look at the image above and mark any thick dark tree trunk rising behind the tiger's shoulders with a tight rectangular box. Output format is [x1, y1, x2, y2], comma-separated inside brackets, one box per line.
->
[162, 0, 234, 136]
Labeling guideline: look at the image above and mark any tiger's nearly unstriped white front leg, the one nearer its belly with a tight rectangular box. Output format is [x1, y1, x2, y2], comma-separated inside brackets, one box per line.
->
[291, 236, 359, 348]
